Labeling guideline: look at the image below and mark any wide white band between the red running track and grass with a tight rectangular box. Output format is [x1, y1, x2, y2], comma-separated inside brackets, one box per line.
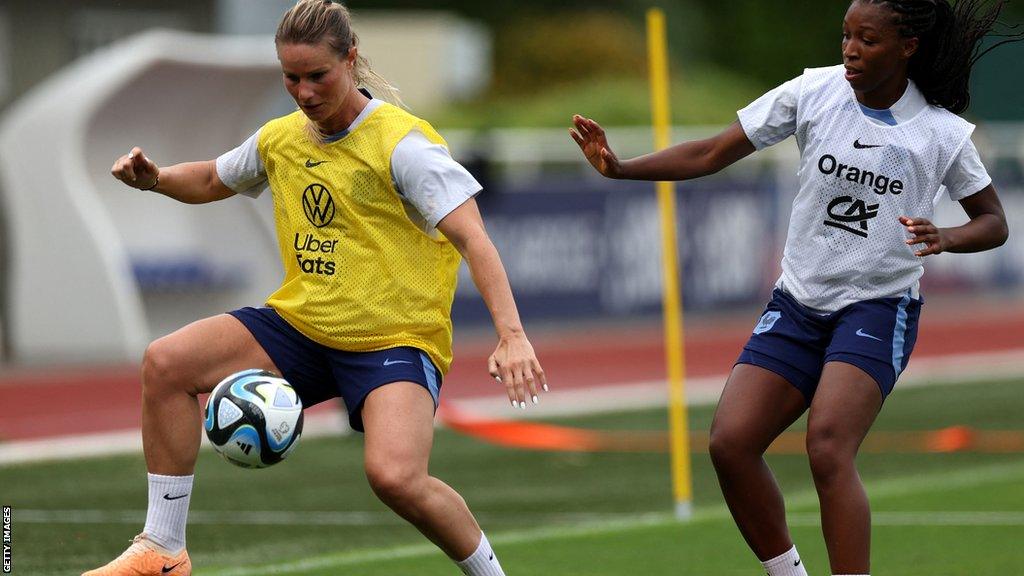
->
[0, 342, 1024, 466]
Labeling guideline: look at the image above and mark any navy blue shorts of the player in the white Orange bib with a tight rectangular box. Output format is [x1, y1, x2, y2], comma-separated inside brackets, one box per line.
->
[736, 289, 923, 405]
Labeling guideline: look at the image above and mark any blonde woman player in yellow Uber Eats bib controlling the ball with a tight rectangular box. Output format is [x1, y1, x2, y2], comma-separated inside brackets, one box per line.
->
[87, 0, 547, 576]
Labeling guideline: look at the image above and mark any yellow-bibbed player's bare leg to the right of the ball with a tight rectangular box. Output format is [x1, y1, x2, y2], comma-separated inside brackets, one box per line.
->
[362, 382, 481, 561]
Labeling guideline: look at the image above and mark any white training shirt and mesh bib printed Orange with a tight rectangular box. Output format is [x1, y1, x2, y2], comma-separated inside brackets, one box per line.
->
[738, 66, 991, 312]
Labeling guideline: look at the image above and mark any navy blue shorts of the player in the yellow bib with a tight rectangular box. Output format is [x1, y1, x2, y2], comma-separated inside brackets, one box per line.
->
[228, 306, 441, 431]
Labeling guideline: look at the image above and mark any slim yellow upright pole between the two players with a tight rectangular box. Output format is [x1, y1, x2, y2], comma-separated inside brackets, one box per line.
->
[647, 8, 693, 520]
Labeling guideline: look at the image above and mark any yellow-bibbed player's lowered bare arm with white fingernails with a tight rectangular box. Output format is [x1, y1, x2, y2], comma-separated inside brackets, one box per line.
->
[437, 199, 547, 408]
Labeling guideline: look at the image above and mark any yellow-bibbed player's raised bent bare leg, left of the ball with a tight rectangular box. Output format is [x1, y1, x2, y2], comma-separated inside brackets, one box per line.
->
[142, 314, 276, 476]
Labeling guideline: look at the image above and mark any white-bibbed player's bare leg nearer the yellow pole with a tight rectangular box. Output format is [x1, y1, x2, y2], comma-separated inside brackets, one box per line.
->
[710, 364, 807, 562]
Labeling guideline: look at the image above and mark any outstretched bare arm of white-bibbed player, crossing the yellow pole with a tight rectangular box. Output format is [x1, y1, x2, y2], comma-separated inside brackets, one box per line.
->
[569, 115, 755, 180]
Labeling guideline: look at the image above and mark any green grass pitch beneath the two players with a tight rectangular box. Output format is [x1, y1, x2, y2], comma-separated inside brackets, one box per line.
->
[0, 381, 1024, 576]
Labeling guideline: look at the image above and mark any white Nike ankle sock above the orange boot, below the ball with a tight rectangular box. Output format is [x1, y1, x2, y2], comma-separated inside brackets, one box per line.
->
[142, 474, 195, 553]
